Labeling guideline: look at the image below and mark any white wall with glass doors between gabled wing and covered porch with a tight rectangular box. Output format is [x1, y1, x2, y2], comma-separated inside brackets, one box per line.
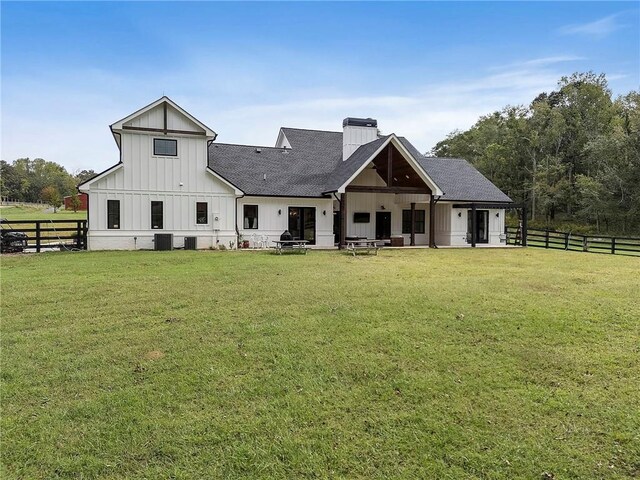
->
[237, 197, 334, 248]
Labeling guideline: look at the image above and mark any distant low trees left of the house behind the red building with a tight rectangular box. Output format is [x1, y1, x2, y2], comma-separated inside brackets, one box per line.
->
[0, 158, 95, 208]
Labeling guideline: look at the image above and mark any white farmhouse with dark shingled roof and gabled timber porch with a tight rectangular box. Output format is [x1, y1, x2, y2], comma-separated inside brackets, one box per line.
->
[78, 97, 511, 250]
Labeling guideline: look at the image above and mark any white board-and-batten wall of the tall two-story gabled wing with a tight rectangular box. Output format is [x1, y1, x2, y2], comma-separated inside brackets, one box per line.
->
[83, 106, 236, 250]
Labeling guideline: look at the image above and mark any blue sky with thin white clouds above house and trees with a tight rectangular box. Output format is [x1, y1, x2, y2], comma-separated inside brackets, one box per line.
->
[0, 1, 640, 171]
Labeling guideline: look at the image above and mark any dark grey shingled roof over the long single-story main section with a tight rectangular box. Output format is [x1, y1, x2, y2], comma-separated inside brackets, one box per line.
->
[209, 128, 511, 202]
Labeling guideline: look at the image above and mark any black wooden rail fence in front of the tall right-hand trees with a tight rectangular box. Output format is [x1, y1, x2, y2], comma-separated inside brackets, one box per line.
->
[505, 227, 640, 256]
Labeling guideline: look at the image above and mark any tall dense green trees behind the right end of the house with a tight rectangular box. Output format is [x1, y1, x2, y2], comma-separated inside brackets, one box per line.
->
[429, 72, 640, 234]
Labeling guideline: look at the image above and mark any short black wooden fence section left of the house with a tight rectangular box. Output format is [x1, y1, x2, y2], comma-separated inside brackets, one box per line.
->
[0, 220, 87, 252]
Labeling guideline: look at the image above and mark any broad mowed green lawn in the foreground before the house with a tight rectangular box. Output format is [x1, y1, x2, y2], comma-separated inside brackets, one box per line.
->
[0, 249, 640, 479]
